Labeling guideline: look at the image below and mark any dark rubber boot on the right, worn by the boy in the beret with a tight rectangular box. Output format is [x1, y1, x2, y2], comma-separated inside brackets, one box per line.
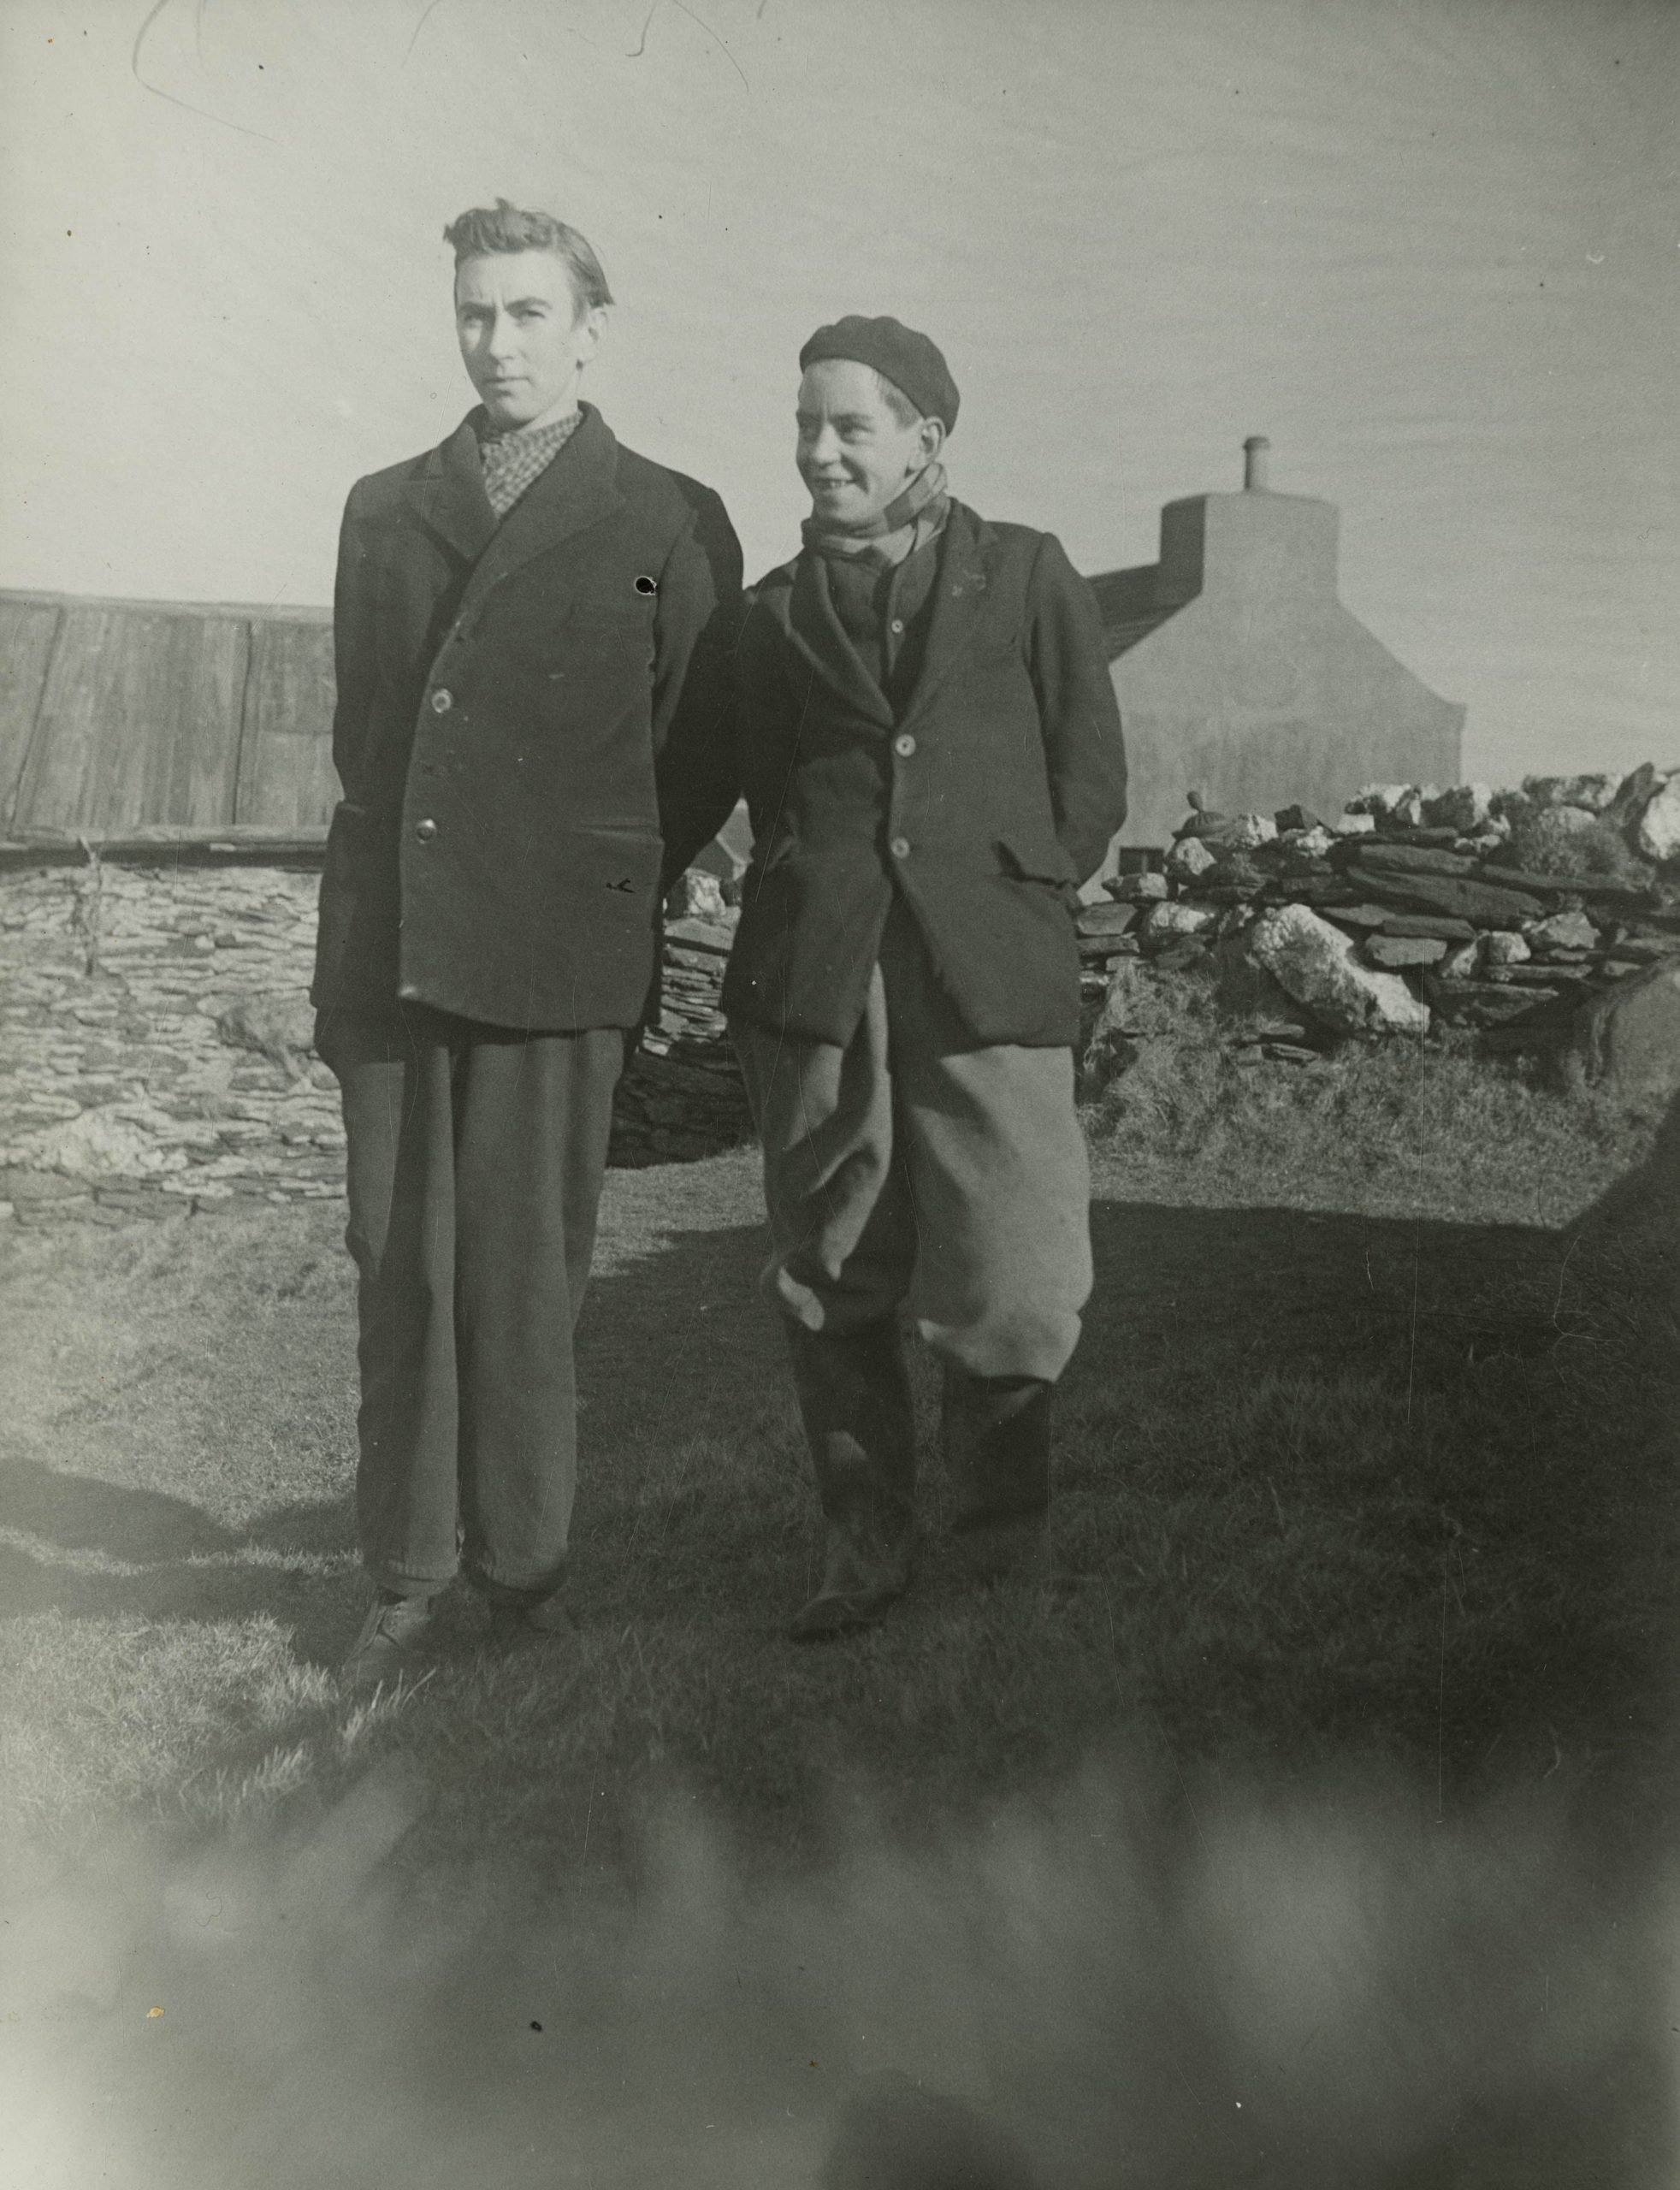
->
[942, 1362, 1054, 1581]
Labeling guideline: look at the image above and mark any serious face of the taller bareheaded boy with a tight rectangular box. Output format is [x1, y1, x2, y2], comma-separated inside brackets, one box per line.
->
[456, 252, 605, 431]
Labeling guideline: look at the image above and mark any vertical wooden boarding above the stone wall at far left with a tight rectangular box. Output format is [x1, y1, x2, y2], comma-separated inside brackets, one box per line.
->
[0, 591, 337, 837]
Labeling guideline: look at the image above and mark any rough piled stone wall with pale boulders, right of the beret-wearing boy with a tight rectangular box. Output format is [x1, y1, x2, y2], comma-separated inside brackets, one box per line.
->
[1080, 766, 1680, 1057]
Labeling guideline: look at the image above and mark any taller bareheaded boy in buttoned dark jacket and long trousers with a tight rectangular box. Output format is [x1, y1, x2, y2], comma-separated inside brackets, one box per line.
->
[313, 199, 740, 1682]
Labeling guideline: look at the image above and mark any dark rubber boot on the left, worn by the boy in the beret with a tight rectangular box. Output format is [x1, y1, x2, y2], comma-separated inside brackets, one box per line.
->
[786, 1317, 915, 1642]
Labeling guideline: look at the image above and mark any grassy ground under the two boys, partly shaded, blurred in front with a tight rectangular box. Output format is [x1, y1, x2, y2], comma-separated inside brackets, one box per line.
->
[0, 1051, 1680, 2190]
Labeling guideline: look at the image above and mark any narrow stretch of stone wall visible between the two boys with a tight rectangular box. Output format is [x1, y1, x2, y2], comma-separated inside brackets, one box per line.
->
[611, 869, 751, 1167]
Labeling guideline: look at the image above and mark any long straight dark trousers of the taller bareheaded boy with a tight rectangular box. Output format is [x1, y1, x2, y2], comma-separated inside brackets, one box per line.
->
[317, 1005, 624, 1601]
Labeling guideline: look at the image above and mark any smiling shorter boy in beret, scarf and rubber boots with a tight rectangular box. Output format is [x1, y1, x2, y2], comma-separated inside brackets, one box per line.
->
[725, 317, 1126, 1640]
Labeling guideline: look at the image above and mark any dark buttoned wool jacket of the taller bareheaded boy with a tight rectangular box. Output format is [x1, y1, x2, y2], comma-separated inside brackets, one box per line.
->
[313, 403, 740, 1029]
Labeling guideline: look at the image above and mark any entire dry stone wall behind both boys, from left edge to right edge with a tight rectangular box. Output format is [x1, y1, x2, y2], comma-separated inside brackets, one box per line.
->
[0, 769, 1680, 1224]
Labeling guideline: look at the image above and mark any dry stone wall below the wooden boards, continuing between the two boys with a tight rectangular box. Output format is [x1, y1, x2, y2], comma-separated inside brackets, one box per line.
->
[0, 861, 747, 1224]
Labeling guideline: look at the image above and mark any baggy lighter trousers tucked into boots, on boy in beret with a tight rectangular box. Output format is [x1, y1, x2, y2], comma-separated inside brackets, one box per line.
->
[731, 907, 1091, 1382]
